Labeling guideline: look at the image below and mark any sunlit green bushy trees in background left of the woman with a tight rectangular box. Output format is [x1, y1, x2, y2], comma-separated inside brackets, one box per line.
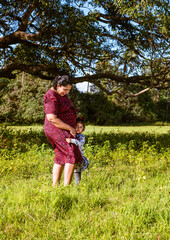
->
[0, 73, 51, 124]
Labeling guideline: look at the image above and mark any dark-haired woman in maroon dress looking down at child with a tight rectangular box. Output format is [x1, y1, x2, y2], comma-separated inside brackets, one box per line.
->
[44, 75, 83, 186]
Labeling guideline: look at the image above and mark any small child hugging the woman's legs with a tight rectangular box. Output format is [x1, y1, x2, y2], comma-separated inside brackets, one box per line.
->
[66, 117, 89, 185]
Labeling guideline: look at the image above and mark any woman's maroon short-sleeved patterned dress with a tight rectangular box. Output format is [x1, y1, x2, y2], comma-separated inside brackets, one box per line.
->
[44, 90, 83, 165]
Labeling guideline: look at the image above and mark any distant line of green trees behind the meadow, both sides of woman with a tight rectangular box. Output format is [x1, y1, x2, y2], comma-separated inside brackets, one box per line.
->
[0, 72, 170, 125]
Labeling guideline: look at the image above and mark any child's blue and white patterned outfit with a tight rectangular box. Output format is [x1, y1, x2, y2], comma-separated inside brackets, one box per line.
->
[71, 133, 89, 172]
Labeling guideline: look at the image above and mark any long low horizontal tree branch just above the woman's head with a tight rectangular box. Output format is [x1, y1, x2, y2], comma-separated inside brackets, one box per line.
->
[0, 63, 170, 97]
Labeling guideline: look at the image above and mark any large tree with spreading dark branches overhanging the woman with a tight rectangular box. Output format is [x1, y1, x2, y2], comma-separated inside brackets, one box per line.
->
[0, 0, 170, 96]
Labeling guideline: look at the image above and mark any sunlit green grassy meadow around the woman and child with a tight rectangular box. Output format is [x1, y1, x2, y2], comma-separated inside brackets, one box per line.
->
[0, 126, 170, 240]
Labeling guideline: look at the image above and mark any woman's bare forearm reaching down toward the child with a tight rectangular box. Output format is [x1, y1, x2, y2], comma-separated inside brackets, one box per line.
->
[46, 114, 76, 137]
